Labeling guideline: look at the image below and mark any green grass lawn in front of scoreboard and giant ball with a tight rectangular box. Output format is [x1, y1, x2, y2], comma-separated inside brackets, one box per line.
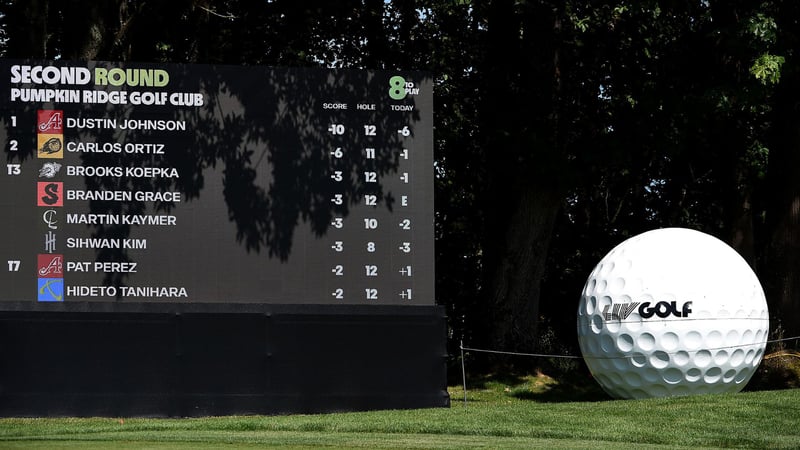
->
[0, 375, 800, 449]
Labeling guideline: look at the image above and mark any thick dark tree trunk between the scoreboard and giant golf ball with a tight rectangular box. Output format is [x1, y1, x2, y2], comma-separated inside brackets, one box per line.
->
[481, 0, 564, 351]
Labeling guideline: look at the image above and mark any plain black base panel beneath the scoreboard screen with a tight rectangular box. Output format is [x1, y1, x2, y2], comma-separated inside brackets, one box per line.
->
[0, 303, 450, 417]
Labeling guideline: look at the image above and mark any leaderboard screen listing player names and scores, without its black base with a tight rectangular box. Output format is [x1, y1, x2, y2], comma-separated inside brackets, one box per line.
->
[0, 60, 435, 310]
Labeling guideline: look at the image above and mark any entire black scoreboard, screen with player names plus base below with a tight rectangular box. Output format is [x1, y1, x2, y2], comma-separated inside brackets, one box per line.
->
[0, 60, 449, 417]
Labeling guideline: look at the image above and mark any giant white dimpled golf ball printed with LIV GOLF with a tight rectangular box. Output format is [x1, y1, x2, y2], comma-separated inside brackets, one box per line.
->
[578, 228, 769, 398]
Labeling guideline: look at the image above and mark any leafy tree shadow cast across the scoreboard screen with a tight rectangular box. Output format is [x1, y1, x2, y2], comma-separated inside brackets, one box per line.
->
[3, 62, 433, 286]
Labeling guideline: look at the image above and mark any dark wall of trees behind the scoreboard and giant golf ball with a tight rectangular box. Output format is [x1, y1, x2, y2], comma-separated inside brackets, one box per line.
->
[0, 0, 800, 350]
